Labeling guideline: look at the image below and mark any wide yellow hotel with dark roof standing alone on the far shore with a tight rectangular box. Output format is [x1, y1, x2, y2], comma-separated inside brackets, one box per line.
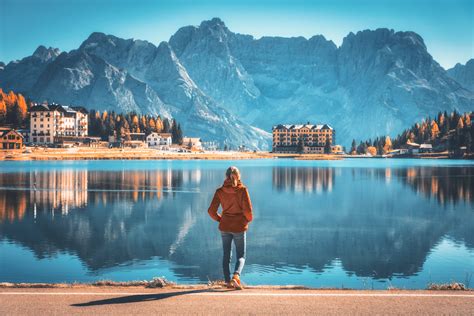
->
[272, 124, 336, 154]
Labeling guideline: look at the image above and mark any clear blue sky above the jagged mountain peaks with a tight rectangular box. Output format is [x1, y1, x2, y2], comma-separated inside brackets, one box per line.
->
[0, 0, 474, 68]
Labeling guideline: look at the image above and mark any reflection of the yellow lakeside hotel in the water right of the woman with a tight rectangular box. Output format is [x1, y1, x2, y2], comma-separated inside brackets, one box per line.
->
[272, 167, 335, 193]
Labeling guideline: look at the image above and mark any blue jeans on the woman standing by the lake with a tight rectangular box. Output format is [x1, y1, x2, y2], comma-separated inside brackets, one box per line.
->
[221, 232, 247, 282]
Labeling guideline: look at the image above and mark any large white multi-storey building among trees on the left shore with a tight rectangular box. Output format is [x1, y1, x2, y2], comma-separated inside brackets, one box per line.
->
[29, 103, 88, 144]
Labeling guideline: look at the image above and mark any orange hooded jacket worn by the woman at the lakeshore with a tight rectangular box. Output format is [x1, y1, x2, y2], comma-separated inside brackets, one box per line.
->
[207, 179, 253, 233]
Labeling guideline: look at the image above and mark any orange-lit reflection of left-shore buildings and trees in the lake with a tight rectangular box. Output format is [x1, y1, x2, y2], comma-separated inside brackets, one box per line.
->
[0, 169, 201, 222]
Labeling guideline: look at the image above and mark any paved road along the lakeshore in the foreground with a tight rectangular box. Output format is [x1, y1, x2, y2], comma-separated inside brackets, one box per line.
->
[0, 287, 474, 315]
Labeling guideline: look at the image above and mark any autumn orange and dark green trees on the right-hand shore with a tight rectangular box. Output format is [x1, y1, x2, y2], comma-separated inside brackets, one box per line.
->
[350, 111, 474, 155]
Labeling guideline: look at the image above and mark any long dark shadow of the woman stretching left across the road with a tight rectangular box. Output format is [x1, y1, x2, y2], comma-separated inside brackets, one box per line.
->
[71, 289, 234, 307]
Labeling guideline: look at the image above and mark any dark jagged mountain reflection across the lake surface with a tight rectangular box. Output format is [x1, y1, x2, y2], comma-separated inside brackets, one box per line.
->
[0, 167, 474, 281]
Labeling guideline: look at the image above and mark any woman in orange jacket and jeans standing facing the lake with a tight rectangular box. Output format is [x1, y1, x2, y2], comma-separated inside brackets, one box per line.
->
[208, 167, 252, 290]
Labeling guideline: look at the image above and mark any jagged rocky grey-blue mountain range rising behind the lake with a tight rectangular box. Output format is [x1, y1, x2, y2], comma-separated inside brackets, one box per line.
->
[0, 18, 474, 149]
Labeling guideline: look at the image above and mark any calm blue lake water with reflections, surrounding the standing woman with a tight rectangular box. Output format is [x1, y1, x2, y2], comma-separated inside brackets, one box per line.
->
[0, 159, 474, 288]
